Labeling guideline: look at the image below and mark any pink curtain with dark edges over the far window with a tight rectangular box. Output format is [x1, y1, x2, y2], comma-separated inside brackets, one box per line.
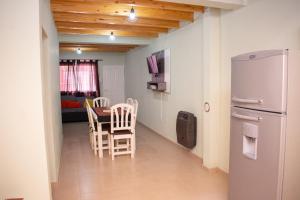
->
[60, 60, 100, 96]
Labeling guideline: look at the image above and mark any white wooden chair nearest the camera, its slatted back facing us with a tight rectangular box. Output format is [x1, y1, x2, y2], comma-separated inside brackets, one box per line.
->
[110, 104, 136, 160]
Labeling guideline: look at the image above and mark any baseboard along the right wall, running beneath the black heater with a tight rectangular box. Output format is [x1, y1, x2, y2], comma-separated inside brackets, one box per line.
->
[138, 121, 228, 176]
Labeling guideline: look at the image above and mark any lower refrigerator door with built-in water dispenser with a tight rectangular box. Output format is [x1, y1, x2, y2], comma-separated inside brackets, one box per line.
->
[229, 108, 286, 200]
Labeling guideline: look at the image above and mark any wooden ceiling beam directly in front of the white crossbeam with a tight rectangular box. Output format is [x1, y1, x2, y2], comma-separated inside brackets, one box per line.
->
[58, 28, 158, 38]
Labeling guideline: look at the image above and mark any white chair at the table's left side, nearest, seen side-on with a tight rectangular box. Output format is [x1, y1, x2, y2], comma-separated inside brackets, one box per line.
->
[88, 106, 110, 158]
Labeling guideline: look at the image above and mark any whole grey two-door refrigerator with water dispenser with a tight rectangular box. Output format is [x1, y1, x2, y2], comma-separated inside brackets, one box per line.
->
[229, 49, 300, 200]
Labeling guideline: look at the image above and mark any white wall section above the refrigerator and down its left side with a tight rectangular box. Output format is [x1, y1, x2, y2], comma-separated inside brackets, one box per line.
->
[218, 0, 300, 171]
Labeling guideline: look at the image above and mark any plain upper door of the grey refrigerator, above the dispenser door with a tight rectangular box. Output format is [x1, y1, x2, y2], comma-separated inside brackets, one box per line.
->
[231, 50, 287, 112]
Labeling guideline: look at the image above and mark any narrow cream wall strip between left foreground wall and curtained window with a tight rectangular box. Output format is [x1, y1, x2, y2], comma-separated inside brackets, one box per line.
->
[40, 0, 63, 182]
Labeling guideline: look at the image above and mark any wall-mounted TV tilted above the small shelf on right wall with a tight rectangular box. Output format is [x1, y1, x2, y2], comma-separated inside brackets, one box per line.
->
[147, 51, 165, 74]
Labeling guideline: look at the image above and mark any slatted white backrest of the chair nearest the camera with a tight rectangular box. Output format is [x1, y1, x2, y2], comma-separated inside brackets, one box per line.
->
[110, 103, 135, 133]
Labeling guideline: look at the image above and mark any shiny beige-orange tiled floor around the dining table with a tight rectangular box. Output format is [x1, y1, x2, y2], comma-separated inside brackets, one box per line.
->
[53, 123, 227, 200]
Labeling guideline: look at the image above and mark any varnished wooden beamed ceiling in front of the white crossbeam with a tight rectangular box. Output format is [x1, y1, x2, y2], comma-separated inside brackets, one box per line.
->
[51, 0, 204, 51]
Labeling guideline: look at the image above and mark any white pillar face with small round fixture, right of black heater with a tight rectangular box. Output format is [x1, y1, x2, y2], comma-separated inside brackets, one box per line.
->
[201, 8, 220, 168]
